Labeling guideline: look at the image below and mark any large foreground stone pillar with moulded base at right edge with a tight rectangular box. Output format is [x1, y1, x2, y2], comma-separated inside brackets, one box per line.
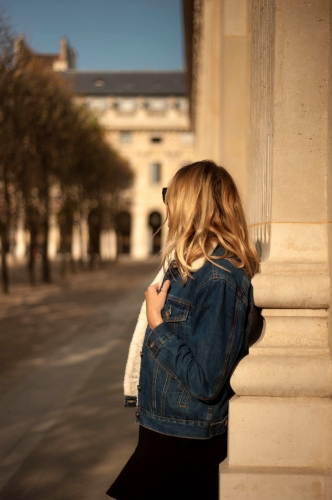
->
[220, 0, 332, 500]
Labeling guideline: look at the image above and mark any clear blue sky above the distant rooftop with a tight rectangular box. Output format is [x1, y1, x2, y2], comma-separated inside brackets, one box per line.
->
[0, 0, 184, 70]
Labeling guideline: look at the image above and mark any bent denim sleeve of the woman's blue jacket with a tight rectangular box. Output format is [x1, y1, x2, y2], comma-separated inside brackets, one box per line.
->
[147, 279, 246, 402]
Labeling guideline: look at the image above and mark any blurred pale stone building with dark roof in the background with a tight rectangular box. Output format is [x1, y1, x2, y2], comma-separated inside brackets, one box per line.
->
[15, 36, 194, 259]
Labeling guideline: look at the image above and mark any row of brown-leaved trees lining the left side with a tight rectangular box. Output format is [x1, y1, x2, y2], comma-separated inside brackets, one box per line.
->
[0, 15, 132, 292]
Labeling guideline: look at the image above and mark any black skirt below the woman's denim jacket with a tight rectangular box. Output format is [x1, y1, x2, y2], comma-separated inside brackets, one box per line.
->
[106, 425, 227, 500]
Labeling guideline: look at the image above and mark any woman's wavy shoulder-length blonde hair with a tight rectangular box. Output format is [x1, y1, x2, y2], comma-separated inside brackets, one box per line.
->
[162, 160, 259, 283]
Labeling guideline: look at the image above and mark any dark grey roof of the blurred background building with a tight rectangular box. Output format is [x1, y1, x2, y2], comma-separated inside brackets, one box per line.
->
[62, 70, 186, 96]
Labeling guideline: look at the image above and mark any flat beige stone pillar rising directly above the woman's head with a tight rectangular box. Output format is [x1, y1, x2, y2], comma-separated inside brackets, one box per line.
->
[194, 0, 251, 196]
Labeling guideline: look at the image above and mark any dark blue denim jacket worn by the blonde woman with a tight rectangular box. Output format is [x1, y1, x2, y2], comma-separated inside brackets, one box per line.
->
[136, 247, 253, 439]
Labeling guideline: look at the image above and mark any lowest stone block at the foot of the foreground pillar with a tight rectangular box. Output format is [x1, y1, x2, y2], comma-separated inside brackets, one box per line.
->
[219, 459, 332, 500]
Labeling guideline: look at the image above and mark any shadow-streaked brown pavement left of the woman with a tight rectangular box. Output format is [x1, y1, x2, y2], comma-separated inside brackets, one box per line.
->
[0, 261, 158, 500]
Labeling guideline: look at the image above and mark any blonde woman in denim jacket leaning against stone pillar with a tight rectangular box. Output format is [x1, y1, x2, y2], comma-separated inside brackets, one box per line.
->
[107, 161, 258, 500]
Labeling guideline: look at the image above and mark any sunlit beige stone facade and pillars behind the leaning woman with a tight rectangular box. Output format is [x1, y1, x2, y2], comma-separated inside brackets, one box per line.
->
[183, 0, 332, 500]
